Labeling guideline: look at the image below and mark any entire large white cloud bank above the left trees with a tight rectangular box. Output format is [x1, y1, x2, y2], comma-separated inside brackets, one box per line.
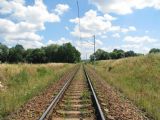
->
[0, 0, 69, 48]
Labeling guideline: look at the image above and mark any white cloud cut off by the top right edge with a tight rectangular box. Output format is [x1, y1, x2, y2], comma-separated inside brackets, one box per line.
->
[90, 0, 160, 15]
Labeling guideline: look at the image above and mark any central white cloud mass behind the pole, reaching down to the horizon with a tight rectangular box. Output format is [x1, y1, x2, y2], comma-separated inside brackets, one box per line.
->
[70, 10, 139, 56]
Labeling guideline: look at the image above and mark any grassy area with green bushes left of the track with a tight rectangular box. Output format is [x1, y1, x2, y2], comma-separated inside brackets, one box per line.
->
[0, 64, 74, 119]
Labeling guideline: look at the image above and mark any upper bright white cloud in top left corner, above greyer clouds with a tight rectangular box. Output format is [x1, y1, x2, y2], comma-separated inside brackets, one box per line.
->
[0, 0, 60, 25]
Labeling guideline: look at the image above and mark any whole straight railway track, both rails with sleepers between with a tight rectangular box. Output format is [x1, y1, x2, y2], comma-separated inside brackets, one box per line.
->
[39, 66, 105, 120]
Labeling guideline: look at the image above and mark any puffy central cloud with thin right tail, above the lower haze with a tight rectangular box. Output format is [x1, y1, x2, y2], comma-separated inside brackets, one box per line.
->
[70, 9, 136, 38]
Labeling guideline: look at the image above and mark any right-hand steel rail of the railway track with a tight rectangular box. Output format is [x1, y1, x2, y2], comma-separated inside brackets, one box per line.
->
[83, 66, 105, 120]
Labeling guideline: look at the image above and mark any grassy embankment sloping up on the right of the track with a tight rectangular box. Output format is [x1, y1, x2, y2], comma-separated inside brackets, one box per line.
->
[89, 54, 160, 120]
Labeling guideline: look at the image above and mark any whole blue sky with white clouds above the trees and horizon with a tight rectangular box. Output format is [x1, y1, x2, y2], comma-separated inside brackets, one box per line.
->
[0, 0, 160, 58]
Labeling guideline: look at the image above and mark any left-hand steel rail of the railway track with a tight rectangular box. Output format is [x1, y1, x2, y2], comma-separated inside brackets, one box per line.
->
[39, 68, 79, 120]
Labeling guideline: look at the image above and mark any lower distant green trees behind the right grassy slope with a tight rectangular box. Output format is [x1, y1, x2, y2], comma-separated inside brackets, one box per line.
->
[90, 48, 160, 61]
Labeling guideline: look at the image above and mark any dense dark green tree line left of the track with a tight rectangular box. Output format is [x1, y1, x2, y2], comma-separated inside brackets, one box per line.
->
[0, 43, 81, 63]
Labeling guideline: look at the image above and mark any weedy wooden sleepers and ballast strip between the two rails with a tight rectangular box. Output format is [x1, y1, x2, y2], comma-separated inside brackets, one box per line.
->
[50, 66, 96, 120]
